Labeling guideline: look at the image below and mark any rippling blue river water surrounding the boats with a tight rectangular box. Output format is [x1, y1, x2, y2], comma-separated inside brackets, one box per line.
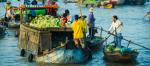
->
[0, 2, 150, 66]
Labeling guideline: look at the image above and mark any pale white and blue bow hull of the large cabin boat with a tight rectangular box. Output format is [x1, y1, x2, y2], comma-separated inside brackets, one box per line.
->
[35, 48, 89, 64]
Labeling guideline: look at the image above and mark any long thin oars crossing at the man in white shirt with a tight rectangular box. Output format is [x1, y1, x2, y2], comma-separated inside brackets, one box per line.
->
[97, 27, 150, 50]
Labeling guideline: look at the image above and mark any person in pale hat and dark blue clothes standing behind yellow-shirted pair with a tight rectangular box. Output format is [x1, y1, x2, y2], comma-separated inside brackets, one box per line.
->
[88, 6, 95, 39]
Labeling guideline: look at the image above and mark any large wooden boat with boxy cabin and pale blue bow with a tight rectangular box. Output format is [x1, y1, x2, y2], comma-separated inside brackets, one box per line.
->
[18, 24, 102, 64]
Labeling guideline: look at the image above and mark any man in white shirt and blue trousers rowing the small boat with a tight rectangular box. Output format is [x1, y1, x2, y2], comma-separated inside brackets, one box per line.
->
[109, 15, 123, 47]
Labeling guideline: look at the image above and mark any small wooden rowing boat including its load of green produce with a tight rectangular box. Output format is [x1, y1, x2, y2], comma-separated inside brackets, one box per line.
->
[103, 45, 139, 62]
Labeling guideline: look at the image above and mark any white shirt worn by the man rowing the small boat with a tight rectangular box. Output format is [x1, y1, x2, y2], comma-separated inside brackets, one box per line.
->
[109, 20, 123, 34]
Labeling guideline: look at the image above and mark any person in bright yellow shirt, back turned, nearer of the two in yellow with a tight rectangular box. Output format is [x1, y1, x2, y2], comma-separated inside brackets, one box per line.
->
[72, 15, 85, 48]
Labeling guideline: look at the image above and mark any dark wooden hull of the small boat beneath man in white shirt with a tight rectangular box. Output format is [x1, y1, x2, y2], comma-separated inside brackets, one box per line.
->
[103, 45, 139, 62]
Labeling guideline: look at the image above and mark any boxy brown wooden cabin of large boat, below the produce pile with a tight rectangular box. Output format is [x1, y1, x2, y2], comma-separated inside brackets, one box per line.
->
[18, 24, 73, 52]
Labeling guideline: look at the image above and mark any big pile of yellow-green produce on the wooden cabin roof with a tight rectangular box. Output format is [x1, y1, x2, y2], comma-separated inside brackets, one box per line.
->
[30, 15, 71, 28]
